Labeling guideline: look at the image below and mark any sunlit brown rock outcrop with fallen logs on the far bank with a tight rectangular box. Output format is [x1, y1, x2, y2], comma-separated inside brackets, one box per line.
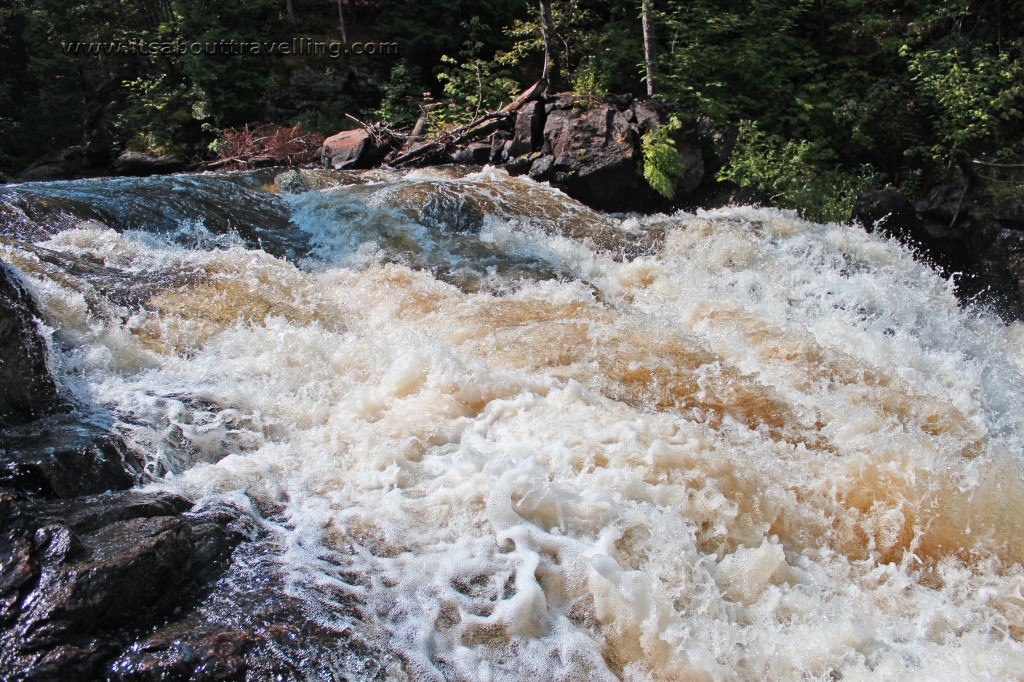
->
[323, 91, 733, 213]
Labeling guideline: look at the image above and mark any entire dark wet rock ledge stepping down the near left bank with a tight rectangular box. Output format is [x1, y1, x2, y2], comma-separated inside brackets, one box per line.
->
[0, 263, 252, 681]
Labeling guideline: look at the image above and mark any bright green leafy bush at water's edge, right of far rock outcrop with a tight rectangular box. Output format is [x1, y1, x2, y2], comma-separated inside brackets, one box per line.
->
[719, 121, 882, 221]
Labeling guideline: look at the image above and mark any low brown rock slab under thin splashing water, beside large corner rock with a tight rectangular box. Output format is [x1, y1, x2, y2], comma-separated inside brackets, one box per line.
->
[106, 542, 395, 682]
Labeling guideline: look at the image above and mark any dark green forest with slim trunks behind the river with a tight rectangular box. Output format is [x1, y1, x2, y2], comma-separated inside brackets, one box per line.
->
[0, 0, 1024, 217]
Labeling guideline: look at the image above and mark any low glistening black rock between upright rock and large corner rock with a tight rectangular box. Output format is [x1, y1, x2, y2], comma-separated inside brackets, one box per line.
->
[0, 414, 139, 499]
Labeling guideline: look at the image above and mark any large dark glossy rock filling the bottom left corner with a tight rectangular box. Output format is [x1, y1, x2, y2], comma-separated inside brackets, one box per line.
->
[0, 492, 244, 680]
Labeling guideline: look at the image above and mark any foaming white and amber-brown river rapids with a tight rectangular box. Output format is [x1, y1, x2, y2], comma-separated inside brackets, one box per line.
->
[0, 169, 1024, 680]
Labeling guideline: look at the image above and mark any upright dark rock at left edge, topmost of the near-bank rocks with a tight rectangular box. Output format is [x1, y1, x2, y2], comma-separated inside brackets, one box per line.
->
[0, 262, 63, 428]
